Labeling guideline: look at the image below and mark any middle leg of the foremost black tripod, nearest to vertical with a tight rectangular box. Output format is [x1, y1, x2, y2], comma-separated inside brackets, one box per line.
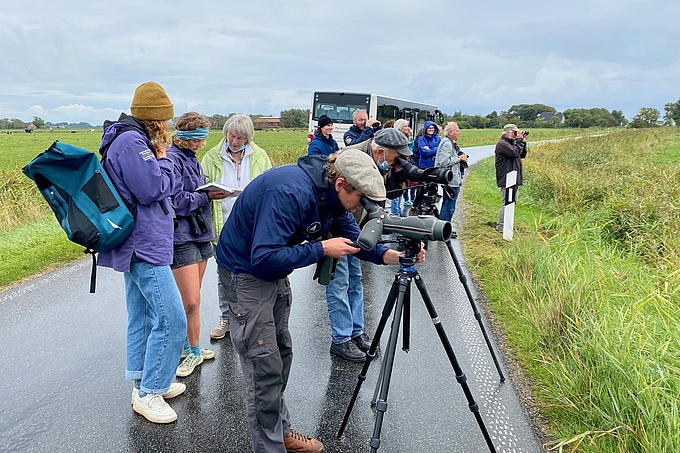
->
[369, 275, 411, 453]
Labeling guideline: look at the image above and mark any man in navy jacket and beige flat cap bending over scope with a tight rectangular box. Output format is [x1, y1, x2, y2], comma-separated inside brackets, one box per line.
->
[216, 149, 425, 453]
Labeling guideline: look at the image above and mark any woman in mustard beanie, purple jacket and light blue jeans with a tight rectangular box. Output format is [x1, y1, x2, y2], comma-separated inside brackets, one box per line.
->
[98, 82, 187, 423]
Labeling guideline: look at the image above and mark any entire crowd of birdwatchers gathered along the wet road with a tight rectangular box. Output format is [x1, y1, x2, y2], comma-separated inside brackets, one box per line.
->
[99, 82, 526, 453]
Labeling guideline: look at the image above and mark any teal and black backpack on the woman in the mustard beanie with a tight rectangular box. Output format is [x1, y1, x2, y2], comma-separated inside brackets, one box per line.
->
[22, 141, 134, 293]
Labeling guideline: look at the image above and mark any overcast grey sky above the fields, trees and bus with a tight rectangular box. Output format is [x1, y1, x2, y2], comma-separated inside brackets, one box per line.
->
[0, 0, 680, 125]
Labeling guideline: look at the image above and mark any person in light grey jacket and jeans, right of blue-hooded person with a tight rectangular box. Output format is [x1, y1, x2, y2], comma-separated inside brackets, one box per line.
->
[434, 122, 467, 228]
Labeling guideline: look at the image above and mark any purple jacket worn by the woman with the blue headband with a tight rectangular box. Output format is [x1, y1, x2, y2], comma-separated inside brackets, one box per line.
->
[168, 144, 215, 244]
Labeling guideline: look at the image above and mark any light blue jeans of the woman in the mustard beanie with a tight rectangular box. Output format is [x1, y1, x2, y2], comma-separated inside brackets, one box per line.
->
[123, 261, 187, 394]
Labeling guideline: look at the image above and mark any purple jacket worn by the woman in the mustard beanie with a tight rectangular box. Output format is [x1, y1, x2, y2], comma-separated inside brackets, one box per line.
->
[98, 117, 175, 272]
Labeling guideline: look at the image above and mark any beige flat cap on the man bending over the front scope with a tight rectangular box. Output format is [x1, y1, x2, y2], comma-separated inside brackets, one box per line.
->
[335, 148, 387, 201]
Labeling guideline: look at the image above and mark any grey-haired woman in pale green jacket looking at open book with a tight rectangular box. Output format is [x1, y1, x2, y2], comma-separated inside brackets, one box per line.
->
[201, 114, 272, 340]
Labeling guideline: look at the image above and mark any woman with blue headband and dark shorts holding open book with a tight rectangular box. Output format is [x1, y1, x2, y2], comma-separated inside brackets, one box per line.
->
[167, 112, 227, 377]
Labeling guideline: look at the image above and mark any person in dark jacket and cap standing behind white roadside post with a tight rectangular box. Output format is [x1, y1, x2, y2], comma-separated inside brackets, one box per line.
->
[494, 124, 527, 232]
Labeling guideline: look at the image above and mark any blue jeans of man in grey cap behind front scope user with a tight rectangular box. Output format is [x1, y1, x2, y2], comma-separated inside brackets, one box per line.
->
[326, 255, 364, 344]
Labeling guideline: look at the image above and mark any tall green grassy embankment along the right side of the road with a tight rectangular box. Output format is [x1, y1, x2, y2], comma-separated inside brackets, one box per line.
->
[460, 128, 680, 453]
